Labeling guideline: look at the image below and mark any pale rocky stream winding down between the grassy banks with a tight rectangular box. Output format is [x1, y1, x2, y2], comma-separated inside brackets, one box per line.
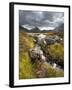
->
[29, 34, 63, 71]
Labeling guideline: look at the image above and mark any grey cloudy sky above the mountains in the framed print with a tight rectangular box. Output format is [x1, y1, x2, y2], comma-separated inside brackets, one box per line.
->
[19, 10, 64, 30]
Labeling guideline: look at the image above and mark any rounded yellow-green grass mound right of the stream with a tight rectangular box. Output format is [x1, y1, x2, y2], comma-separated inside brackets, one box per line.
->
[48, 43, 64, 67]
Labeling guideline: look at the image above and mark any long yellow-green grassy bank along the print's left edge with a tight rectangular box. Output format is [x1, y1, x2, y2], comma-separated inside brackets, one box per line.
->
[19, 31, 35, 79]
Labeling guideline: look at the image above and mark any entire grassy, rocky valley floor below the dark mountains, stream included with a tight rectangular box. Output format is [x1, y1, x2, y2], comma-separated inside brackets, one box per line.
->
[19, 31, 64, 79]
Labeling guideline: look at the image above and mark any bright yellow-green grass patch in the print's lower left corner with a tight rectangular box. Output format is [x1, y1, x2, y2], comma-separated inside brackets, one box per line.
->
[19, 52, 35, 79]
